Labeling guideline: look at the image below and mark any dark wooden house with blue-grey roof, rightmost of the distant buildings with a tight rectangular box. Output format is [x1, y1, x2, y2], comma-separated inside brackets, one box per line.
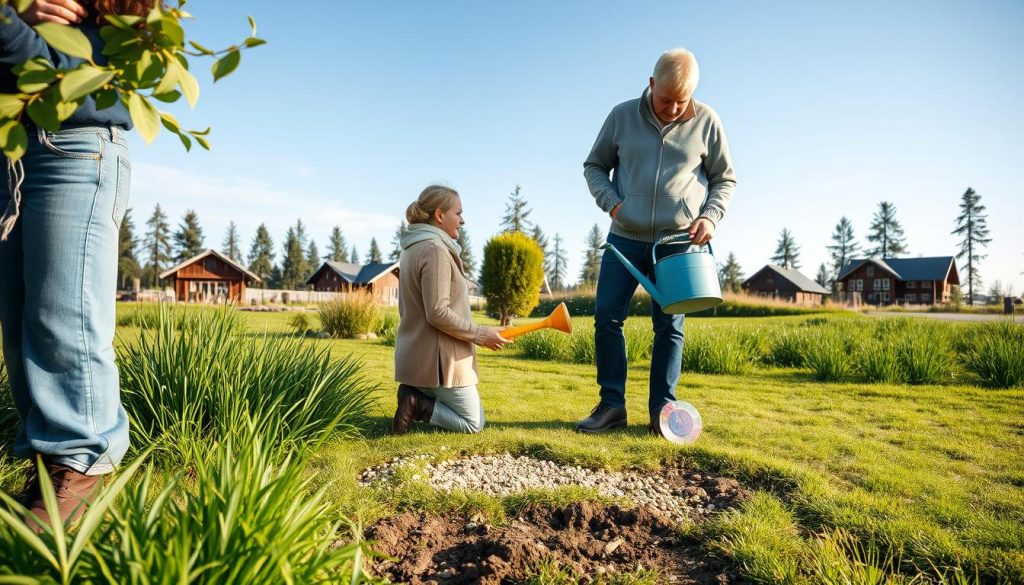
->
[836, 256, 959, 305]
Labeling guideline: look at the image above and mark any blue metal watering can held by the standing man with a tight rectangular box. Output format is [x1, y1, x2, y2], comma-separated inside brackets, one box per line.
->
[601, 234, 722, 315]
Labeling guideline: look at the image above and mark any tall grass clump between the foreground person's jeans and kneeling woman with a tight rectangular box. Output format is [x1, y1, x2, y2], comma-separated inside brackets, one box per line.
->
[119, 305, 373, 459]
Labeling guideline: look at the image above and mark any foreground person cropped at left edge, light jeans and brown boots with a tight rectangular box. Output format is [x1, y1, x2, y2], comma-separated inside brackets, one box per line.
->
[0, 0, 154, 530]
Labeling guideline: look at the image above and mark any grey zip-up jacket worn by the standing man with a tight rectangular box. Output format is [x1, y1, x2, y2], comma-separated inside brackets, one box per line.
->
[583, 88, 736, 242]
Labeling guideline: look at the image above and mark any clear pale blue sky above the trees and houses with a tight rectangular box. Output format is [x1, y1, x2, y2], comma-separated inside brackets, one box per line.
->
[132, 0, 1024, 294]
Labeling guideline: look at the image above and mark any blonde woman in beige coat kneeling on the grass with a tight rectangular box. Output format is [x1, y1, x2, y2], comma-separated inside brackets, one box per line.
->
[392, 185, 509, 434]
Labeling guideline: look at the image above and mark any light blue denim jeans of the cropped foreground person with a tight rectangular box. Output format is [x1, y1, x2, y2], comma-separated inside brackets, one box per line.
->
[0, 127, 131, 475]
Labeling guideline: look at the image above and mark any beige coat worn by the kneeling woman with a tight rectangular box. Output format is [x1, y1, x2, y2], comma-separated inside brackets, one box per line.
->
[394, 239, 485, 388]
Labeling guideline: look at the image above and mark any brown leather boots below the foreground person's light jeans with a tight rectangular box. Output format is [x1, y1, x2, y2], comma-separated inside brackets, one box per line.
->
[23, 463, 103, 532]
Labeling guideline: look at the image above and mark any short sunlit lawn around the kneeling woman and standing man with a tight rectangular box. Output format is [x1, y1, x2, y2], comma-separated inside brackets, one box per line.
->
[0, 307, 1024, 583]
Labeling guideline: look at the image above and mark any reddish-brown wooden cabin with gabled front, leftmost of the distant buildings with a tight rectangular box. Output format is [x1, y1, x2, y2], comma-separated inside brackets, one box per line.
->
[160, 249, 263, 302]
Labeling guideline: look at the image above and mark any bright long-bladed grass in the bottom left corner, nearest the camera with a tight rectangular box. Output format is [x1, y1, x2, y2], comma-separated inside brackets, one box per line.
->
[0, 437, 372, 585]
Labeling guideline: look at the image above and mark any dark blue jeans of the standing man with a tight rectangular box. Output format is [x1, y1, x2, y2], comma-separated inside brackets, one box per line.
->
[594, 234, 683, 415]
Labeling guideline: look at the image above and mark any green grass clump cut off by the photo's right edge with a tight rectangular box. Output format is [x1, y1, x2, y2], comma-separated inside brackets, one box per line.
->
[964, 321, 1024, 388]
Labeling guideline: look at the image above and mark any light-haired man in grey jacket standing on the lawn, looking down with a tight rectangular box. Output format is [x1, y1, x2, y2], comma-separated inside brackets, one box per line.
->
[577, 49, 736, 434]
